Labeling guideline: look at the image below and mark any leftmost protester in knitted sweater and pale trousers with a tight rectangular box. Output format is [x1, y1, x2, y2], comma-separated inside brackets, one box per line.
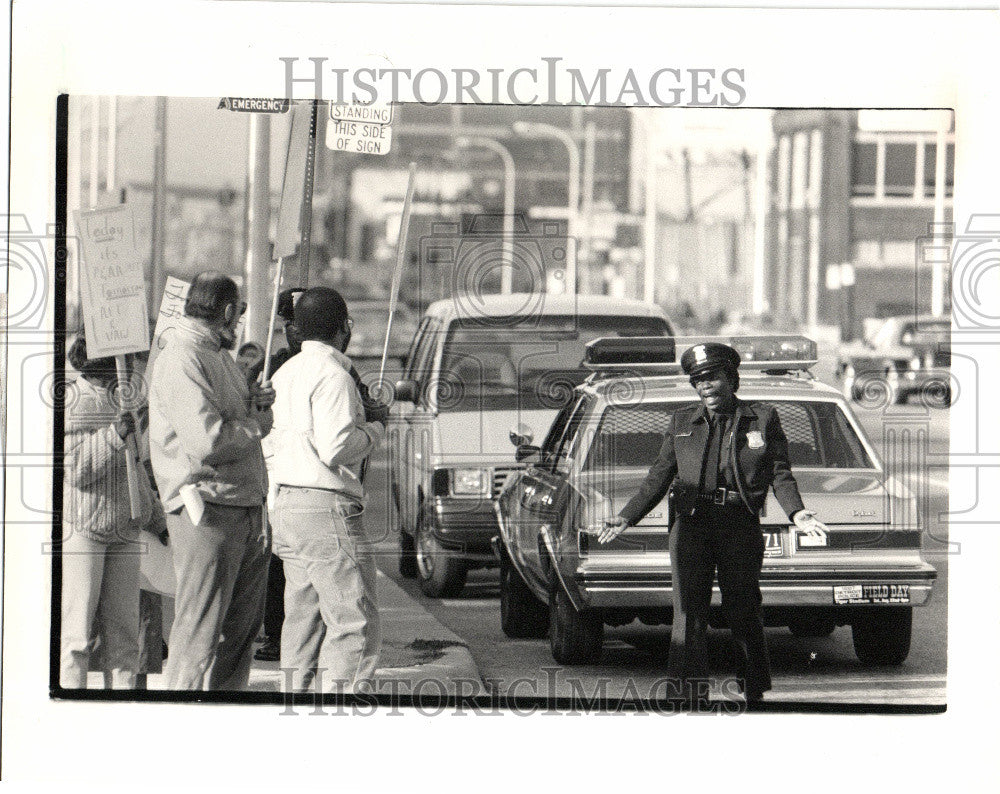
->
[60, 337, 163, 689]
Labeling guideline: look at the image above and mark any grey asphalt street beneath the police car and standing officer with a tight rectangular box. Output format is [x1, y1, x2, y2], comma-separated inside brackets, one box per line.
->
[368, 406, 948, 705]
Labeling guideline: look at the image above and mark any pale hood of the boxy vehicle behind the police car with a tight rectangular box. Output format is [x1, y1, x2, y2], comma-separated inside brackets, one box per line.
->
[435, 409, 557, 458]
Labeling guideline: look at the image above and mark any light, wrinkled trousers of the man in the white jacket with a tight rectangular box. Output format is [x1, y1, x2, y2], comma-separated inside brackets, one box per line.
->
[273, 486, 381, 693]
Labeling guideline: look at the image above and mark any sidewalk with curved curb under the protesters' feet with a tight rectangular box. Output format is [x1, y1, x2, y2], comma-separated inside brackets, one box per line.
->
[145, 571, 485, 698]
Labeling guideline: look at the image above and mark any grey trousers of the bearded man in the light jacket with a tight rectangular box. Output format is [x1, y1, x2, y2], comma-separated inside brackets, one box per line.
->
[167, 503, 270, 691]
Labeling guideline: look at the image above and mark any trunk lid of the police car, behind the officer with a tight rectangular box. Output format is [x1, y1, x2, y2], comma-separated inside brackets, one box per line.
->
[580, 469, 904, 526]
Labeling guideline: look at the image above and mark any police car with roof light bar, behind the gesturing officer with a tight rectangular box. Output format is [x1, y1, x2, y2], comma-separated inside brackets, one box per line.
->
[494, 337, 936, 664]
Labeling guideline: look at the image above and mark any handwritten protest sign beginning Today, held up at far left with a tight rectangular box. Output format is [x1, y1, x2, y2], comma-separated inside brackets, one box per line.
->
[76, 204, 149, 358]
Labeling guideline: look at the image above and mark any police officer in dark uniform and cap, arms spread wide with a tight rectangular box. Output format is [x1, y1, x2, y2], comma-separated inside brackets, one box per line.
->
[598, 342, 822, 702]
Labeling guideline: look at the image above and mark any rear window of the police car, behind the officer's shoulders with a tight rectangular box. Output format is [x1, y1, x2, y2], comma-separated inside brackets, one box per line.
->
[584, 400, 874, 471]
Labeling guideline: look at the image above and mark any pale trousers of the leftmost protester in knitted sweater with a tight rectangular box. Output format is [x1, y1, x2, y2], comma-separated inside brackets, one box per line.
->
[60, 532, 140, 689]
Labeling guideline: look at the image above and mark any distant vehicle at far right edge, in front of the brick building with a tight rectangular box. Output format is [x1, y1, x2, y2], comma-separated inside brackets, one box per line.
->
[837, 315, 953, 407]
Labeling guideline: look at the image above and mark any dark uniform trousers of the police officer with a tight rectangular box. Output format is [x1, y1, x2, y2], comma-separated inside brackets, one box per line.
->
[667, 504, 771, 699]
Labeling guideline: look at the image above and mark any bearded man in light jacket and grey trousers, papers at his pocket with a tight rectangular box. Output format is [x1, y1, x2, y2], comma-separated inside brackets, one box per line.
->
[149, 271, 274, 690]
